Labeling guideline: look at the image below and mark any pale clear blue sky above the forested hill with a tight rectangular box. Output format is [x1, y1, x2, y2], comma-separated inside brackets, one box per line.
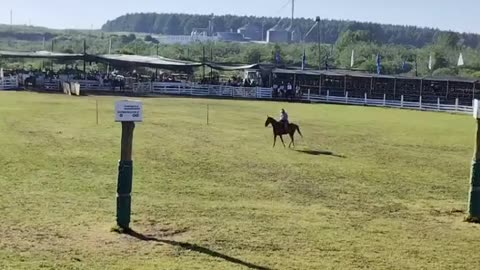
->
[0, 0, 480, 33]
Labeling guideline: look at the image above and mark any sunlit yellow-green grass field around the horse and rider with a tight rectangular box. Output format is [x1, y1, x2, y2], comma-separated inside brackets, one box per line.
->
[0, 92, 480, 269]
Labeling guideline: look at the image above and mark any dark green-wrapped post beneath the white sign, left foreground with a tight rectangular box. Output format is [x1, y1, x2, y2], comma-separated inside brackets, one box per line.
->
[117, 122, 135, 229]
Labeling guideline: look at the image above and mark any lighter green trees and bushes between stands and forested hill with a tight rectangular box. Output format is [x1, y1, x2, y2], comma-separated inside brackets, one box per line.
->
[0, 24, 480, 78]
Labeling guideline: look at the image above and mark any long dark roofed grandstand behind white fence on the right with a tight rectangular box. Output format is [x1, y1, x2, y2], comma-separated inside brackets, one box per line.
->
[272, 68, 480, 106]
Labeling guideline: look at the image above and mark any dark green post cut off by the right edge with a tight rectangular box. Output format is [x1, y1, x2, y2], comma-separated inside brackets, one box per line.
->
[468, 119, 480, 222]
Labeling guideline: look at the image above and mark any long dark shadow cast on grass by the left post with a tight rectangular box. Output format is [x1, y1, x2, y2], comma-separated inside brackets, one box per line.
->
[124, 230, 272, 270]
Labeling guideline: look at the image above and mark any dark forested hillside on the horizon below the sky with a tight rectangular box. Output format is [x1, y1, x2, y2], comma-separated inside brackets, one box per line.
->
[102, 13, 480, 48]
